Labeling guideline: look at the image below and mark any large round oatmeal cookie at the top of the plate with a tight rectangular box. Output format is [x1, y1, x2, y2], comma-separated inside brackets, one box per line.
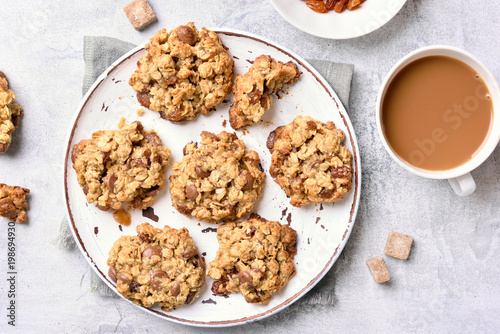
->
[129, 22, 234, 122]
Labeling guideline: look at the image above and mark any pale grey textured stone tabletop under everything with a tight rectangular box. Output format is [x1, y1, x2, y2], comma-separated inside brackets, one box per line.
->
[0, 0, 500, 334]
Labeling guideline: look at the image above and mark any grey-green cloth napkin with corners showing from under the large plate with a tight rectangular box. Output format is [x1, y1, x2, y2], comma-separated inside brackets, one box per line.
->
[56, 36, 354, 305]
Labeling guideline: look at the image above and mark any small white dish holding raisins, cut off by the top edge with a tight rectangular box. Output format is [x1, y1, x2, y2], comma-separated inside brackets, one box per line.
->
[270, 0, 406, 39]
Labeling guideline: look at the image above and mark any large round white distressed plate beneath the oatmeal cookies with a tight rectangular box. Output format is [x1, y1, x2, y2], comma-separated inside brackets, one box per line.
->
[64, 29, 361, 327]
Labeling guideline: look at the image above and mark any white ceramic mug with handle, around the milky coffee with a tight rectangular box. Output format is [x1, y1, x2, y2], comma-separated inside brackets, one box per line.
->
[376, 45, 500, 196]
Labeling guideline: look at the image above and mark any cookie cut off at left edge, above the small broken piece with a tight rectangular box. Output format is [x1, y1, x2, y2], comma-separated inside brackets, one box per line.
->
[0, 71, 23, 154]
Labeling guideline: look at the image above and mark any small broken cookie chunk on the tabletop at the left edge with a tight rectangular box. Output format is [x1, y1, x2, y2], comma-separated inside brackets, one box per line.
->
[0, 183, 30, 223]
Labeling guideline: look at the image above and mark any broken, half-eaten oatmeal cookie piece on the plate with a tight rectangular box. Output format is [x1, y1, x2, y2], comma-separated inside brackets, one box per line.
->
[229, 55, 301, 130]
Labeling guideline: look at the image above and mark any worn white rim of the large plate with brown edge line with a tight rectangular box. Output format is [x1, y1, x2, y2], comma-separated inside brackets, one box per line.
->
[62, 28, 361, 328]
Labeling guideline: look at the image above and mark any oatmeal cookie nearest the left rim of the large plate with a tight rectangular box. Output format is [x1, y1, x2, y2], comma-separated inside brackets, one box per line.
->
[71, 122, 170, 210]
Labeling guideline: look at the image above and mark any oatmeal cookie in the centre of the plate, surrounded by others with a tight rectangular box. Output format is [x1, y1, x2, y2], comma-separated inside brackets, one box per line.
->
[170, 131, 266, 223]
